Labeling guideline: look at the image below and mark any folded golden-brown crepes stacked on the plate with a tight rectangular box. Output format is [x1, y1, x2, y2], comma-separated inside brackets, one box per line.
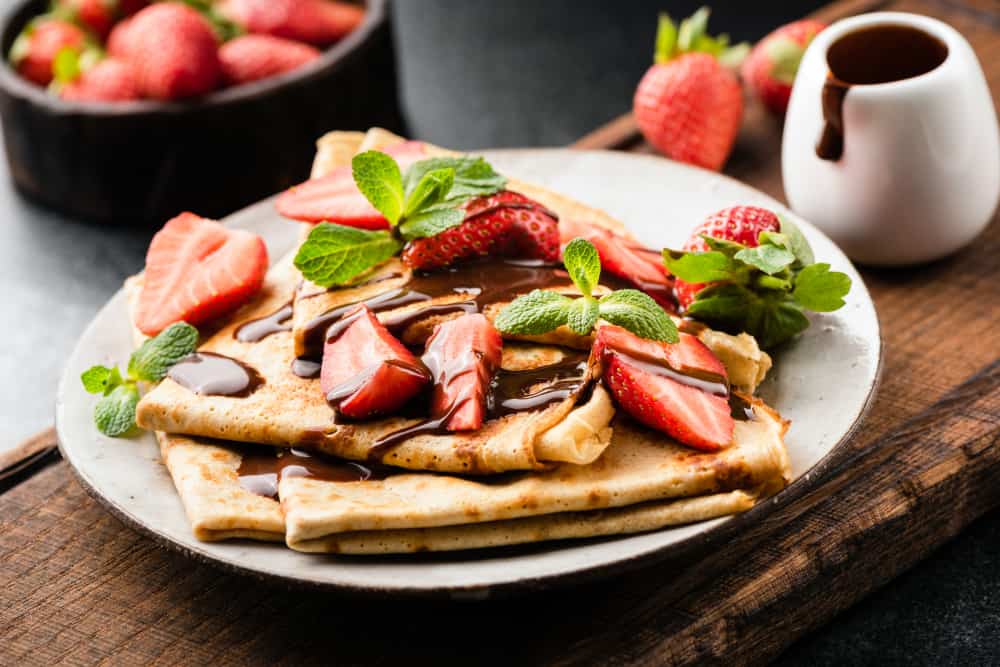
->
[133, 129, 789, 554]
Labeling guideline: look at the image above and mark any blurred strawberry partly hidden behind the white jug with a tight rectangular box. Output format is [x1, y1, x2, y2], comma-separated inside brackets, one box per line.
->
[742, 19, 826, 116]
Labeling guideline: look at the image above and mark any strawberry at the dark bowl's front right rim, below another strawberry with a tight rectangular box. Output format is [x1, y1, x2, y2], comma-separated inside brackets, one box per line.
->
[219, 35, 320, 84]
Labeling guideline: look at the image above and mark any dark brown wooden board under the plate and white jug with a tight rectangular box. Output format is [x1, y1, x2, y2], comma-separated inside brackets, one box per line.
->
[0, 0, 1000, 665]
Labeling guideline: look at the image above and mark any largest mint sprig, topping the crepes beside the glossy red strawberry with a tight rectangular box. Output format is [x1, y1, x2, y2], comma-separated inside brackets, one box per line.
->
[295, 151, 507, 287]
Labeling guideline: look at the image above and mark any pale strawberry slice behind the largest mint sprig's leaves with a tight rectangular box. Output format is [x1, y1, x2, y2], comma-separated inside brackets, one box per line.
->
[275, 141, 427, 229]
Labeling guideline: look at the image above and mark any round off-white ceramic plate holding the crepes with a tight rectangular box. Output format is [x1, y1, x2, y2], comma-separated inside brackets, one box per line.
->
[56, 149, 881, 596]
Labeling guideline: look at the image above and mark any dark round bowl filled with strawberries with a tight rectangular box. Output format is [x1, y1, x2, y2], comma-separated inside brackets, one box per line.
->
[0, 0, 402, 225]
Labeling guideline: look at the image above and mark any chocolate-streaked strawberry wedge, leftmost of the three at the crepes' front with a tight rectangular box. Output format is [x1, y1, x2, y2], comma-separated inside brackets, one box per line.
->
[320, 305, 430, 419]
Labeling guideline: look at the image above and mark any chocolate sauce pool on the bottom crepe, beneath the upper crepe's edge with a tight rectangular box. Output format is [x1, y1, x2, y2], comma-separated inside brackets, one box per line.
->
[236, 446, 393, 500]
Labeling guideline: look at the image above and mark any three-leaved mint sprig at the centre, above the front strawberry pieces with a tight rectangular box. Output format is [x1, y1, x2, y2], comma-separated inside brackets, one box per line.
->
[493, 238, 679, 343]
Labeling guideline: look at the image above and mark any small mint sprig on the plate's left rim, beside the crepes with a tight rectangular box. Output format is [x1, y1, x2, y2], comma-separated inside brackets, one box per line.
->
[80, 322, 198, 438]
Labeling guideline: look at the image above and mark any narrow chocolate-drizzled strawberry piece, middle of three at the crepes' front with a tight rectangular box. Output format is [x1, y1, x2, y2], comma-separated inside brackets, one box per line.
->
[423, 313, 503, 431]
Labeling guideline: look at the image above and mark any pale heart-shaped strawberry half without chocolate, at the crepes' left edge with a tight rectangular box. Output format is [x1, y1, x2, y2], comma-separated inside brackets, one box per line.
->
[135, 213, 267, 336]
